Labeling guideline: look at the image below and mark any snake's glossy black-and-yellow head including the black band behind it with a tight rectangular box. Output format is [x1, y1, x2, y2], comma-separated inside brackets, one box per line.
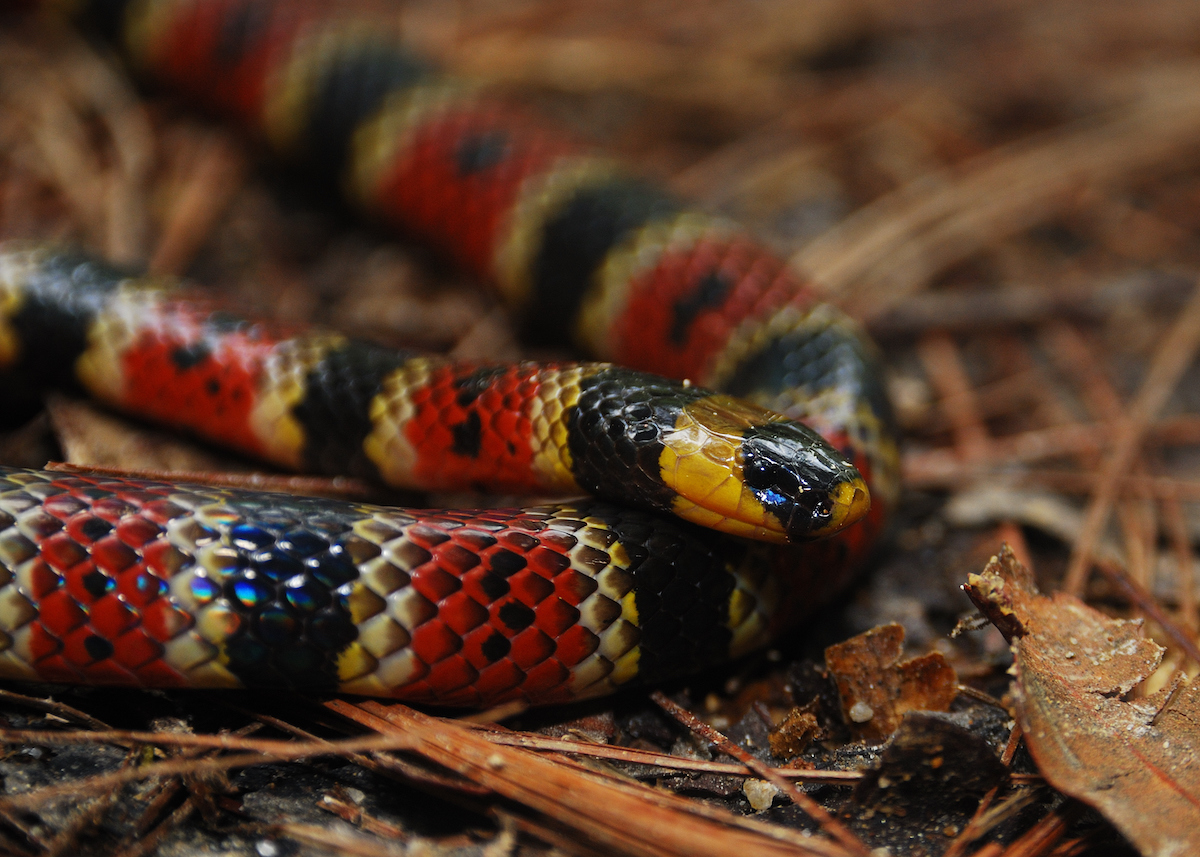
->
[569, 367, 870, 544]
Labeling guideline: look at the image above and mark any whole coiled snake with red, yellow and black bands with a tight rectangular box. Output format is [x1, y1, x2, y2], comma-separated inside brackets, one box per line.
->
[0, 0, 899, 707]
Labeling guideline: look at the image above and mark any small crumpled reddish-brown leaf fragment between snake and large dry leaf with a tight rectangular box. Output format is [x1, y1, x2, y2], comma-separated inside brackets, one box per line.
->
[826, 624, 958, 743]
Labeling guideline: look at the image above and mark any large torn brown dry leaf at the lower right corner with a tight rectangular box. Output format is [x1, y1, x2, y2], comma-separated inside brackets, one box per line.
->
[964, 545, 1200, 857]
